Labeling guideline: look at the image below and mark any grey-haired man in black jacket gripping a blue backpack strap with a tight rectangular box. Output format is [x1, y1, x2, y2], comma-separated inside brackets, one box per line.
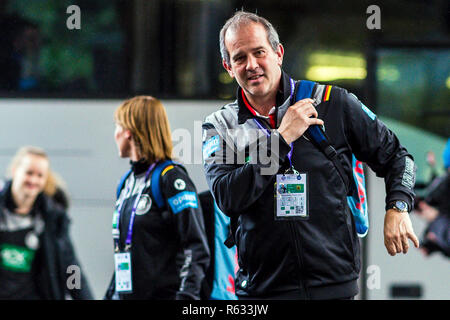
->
[203, 12, 419, 299]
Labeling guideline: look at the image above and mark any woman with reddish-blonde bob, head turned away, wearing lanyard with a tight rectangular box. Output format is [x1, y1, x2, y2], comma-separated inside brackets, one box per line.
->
[105, 96, 209, 300]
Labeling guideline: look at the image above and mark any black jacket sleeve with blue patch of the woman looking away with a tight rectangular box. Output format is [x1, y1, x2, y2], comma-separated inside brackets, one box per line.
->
[161, 166, 210, 300]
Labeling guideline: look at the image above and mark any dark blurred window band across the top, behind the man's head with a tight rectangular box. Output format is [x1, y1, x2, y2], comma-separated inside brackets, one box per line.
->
[0, 0, 450, 137]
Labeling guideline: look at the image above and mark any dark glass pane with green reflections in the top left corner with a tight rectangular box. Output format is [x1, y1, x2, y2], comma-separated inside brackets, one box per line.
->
[0, 0, 129, 97]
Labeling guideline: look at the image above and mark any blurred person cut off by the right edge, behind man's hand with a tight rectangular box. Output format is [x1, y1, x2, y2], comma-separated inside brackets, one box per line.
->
[415, 139, 450, 257]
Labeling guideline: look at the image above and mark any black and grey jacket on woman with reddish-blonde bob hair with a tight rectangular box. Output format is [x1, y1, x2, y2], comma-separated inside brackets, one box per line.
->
[105, 162, 209, 300]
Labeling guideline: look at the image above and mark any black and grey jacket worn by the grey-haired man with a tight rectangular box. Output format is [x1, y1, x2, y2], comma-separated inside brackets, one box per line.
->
[203, 72, 415, 299]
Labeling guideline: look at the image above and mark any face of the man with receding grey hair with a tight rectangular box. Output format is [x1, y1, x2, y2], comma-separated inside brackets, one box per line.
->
[223, 23, 284, 99]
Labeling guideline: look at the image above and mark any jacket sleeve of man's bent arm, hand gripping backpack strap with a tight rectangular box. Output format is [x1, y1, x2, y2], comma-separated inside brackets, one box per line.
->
[202, 122, 291, 217]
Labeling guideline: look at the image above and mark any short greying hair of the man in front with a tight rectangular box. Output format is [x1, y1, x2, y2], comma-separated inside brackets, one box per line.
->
[219, 11, 280, 65]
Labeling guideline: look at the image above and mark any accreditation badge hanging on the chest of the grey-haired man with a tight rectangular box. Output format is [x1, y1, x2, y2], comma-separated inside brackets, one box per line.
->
[275, 173, 309, 220]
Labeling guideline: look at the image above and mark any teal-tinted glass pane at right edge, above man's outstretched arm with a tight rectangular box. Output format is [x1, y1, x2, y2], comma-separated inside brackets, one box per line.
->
[376, 47, 450, 137]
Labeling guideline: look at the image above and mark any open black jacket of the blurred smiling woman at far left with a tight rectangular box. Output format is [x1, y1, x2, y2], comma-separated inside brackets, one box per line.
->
[0, 181, 93, 300]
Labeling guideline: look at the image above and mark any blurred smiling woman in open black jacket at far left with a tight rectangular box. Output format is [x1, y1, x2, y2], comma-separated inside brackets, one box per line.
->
[0, 146, 92, 300]
